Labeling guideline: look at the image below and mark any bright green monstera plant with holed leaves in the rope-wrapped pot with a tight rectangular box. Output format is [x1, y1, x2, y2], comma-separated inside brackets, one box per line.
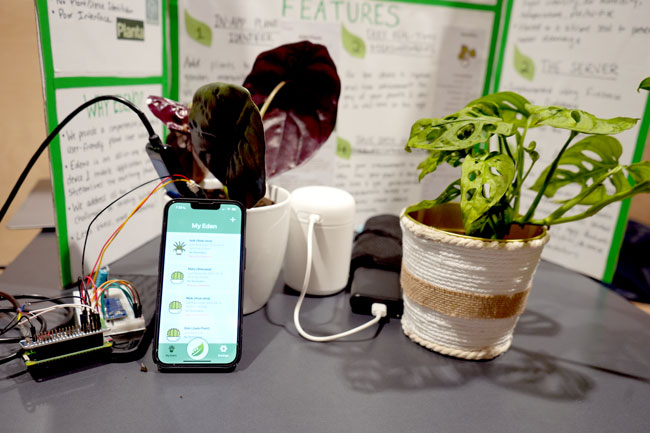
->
[406, 90, 650, 239]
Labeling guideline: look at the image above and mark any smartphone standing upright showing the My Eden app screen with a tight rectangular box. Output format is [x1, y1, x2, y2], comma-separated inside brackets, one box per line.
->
[153, 198, 246, 370]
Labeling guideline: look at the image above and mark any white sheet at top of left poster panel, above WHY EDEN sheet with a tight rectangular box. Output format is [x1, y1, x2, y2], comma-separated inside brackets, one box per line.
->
[47, 0, 163, 78]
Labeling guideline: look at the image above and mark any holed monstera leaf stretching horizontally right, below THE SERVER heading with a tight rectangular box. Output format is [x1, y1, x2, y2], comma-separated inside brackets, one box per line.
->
[528, 105, 638, 134]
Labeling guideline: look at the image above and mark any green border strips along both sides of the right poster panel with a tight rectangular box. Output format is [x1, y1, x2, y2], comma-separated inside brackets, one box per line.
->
[492, 0, 650, 284]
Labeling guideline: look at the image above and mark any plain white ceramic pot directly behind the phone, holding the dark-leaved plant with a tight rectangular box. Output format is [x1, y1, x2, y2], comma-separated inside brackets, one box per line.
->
[244, 185, 291, 314]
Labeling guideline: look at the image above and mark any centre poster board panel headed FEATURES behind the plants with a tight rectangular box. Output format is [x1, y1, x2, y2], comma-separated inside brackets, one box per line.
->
[170, 0, 501, 226]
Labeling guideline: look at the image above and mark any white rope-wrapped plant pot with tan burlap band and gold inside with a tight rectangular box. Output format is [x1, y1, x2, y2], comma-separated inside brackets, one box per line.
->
[400, 203, 549, 359]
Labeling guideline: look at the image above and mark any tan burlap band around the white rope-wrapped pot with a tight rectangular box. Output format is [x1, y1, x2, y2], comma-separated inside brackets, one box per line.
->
[400, 266, 530, 319]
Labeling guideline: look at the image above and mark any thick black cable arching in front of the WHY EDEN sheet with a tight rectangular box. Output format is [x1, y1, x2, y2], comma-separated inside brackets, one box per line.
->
[0, 95, 161, 221]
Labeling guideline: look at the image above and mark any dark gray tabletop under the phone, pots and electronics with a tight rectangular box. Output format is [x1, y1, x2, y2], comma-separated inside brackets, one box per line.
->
[0, 233, 650, 433]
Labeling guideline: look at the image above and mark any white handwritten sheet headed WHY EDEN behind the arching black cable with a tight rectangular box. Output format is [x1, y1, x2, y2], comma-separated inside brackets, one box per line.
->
[55, 85, 164, 276]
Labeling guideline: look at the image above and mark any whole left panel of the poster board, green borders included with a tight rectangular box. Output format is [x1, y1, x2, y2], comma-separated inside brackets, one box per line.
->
[36, 0, 167, 286]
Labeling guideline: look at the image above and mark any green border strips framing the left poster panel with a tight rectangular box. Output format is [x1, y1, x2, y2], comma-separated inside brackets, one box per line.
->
[36, 0, 170, 287]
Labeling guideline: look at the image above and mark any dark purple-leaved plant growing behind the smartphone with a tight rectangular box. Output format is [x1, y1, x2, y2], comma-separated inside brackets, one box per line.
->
[148, 41, 341, 208]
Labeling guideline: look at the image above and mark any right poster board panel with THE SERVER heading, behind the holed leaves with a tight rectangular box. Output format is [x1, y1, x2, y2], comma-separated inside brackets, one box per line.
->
[494, 0, 650, 282]
